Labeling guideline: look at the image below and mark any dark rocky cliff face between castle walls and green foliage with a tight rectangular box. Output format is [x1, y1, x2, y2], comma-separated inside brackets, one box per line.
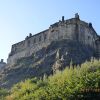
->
[0, 39, 94, 88]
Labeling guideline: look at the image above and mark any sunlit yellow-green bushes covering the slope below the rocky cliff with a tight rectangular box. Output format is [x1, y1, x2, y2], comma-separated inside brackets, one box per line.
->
[3, 60, 100, 100]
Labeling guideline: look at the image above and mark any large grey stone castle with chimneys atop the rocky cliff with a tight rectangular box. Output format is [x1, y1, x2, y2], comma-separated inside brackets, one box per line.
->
[7, 13, 100, 65]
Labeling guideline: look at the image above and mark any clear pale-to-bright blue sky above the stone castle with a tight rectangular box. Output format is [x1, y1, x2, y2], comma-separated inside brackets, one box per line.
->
[0, 0, 100, 61]
